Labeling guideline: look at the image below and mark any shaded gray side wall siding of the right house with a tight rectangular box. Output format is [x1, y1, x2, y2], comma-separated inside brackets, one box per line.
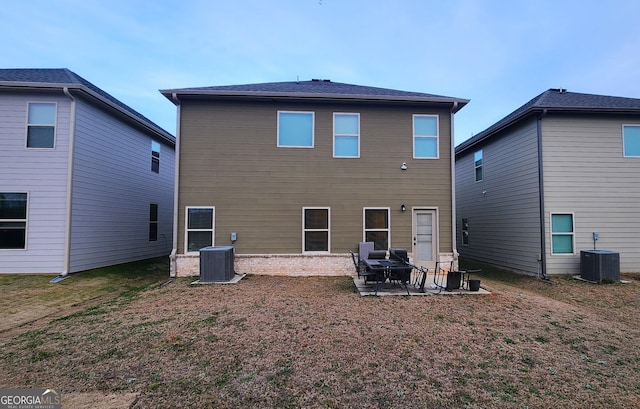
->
[456, 119, 541, 274]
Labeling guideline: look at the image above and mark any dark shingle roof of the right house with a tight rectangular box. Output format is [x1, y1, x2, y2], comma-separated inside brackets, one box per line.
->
[456, 88, 640, 154]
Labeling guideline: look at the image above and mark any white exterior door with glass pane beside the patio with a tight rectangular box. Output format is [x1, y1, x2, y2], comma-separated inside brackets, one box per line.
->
[413, 209, 438, 268]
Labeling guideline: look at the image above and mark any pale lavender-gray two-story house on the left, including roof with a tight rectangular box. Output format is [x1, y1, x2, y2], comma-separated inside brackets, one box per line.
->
[0, 69, 175, 275]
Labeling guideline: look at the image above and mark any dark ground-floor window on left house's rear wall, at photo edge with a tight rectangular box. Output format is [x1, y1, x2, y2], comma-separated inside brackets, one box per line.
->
[0, 192, 27, 249]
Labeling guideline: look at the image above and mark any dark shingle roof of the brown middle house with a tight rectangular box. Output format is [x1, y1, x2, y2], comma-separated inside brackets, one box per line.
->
[160, 80, 469, 110]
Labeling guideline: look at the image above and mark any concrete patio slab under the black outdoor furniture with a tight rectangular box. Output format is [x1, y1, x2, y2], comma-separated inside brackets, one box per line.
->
[353, 274, 491, 297]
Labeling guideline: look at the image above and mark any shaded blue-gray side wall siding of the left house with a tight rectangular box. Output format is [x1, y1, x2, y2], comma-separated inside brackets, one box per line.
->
[70, 99, 175, 272]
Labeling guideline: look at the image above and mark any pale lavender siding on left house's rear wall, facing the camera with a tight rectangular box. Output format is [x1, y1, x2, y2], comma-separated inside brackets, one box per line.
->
[0, 93, 70, 273]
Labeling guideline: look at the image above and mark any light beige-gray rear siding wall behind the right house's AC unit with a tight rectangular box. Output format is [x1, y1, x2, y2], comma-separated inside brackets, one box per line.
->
[543, 116, 640, 274]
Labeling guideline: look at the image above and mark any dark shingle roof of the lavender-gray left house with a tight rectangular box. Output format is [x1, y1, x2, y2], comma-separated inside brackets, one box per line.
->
[0, 68, 175, 140]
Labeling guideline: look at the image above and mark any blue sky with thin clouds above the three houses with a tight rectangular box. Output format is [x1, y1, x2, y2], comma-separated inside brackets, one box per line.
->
[0, 0, 640, 145]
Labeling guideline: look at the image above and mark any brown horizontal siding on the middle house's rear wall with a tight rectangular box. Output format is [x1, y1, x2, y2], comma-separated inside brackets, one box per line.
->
[178, 101, 452, 254]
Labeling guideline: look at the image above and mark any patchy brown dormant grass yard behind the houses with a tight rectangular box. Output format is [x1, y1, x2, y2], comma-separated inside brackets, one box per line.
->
[0, 263, 640, 409]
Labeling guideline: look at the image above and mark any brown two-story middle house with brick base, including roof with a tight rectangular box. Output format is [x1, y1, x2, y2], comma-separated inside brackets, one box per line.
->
[161, 80, 468, 275]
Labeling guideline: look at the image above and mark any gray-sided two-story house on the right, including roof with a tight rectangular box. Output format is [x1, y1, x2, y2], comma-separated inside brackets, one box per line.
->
[455, 89, 640, 274]
